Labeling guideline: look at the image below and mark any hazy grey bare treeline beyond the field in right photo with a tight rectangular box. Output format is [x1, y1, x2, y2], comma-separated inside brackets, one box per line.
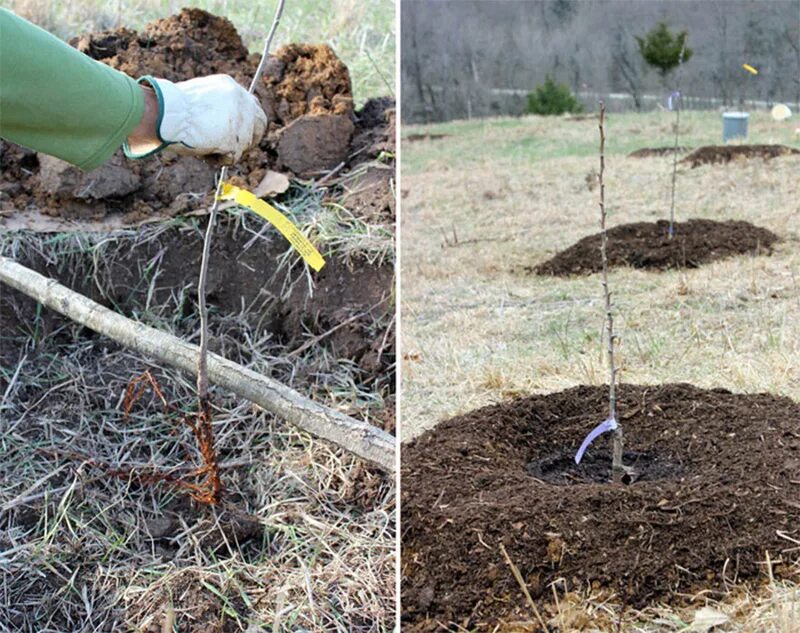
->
[400, 0, 800, 123]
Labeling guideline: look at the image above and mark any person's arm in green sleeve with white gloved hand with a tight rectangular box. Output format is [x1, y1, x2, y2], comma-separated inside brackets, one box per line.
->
[0, 9, 267, 170]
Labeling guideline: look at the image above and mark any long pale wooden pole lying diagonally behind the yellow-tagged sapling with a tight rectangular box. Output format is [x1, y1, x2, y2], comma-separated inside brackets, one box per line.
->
[0, 256, 395, 472]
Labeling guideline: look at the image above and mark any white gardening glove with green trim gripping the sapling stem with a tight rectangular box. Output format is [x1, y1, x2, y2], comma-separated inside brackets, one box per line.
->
[123, 75, 267, 164]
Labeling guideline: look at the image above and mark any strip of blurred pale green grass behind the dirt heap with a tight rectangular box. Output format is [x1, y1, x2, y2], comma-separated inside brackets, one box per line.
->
[0, 0, 395, 104]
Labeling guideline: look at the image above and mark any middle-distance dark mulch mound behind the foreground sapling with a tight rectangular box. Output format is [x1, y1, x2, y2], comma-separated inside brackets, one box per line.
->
[526, 219, 779, 276]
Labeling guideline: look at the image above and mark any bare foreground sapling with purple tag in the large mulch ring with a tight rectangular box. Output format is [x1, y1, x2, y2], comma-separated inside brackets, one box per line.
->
[575, 101, 625, 484]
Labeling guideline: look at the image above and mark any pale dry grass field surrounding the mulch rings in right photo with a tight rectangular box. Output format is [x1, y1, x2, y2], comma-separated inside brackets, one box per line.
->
[401, 112, 800, 632]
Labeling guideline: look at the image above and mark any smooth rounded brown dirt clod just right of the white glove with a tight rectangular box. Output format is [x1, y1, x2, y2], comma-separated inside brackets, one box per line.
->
[277, 114, 355, 174]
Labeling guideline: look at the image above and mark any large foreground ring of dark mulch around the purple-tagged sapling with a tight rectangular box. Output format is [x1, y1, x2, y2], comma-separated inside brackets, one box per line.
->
[402, 384, 800, 632]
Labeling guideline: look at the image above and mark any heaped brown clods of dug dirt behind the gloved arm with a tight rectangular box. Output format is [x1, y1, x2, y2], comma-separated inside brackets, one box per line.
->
[0, 9, 394, 224]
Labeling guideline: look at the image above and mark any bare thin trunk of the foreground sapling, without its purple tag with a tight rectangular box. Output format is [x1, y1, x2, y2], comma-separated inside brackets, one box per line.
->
[599, 101, 625, 484]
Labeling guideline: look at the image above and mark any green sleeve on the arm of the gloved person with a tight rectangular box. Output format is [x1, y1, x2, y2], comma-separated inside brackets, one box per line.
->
[0, 9, 144, 171]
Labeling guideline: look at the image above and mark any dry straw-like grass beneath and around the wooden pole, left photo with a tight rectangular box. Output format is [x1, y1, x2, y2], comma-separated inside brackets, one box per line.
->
[0, 223, 395, 633]
